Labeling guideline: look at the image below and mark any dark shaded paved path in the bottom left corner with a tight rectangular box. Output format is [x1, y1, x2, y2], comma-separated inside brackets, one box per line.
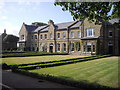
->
[2, 71, 79, 89]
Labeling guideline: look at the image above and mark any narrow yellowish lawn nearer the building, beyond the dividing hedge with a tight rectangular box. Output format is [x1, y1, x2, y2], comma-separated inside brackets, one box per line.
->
[2, 55, 85, 65]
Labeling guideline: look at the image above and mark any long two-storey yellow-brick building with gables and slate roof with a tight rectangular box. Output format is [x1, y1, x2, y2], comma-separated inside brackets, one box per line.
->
[19, 18, 120, 55]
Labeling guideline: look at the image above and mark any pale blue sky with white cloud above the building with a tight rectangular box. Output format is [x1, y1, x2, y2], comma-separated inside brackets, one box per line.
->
[0, 0, 73, 36]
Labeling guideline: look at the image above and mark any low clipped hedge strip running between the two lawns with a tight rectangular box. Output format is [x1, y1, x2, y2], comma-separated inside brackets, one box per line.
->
[11, 55, 109, 70]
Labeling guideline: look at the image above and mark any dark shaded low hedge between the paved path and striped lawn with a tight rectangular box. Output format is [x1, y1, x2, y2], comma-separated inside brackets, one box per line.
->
[12, 69, 118, 90]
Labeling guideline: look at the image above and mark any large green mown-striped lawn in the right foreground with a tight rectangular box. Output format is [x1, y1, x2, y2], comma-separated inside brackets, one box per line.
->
[30, 56, 119, 88]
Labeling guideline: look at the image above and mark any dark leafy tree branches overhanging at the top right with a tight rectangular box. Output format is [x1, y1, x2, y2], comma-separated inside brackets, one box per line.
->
[54, 0, 120, 23]
